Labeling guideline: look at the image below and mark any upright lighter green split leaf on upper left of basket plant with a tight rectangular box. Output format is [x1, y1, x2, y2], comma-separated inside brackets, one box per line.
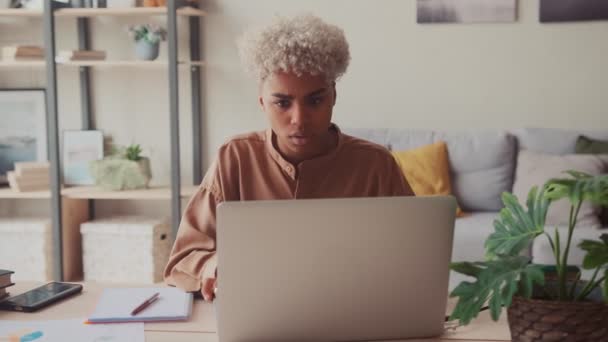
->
[485, 187, 549, 259]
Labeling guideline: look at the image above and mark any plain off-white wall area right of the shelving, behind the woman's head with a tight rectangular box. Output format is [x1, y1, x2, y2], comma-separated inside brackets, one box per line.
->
[205, 0, 608, 166]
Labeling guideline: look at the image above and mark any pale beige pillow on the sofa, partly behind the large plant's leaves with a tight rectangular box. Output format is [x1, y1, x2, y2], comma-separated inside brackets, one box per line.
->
[513, 150, 604, 227]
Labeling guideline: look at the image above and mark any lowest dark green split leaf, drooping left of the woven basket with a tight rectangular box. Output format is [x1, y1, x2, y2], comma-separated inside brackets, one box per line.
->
[450, 255, 544, 325]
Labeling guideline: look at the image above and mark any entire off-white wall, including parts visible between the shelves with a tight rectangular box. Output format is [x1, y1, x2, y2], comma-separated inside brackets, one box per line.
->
[0, 0, 608, 198]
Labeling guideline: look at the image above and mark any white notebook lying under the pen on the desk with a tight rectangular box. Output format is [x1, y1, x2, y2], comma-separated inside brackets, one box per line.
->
[88, 287, 192, 323]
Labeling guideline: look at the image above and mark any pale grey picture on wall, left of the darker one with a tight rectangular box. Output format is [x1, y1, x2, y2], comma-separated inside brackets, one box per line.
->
[417, 0, 517, 23]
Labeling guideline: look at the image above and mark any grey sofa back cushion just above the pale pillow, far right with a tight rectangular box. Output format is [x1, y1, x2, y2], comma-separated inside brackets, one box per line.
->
[512, 128, 608, 154]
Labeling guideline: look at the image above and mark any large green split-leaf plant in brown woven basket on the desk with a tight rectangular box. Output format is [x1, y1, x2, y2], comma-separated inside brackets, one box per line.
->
[450, 171, 608, 341]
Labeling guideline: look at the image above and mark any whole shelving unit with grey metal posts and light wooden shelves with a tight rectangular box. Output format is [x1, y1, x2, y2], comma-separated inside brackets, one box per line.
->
[0, 0, 205, 280]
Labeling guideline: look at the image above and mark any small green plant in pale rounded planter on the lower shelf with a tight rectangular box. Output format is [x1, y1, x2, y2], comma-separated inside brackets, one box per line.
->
[91, 144, 152, 190]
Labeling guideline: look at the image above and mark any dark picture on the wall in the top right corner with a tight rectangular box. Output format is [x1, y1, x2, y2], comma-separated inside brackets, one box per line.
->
[540, 0, 608, 23]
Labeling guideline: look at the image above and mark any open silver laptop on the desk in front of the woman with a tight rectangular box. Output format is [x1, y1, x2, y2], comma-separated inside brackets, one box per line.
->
[216, 196, 456, 342]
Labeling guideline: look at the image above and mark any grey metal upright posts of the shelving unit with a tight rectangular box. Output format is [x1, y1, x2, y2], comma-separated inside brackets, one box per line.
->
[35, 0, 202, 281]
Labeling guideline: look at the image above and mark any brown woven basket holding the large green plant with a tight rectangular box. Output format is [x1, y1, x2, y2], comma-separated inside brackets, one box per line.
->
[507, 296, 608, 342]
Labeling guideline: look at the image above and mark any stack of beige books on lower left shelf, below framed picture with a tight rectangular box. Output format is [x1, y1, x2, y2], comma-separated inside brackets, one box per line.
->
[6, 162, 50, 192]
